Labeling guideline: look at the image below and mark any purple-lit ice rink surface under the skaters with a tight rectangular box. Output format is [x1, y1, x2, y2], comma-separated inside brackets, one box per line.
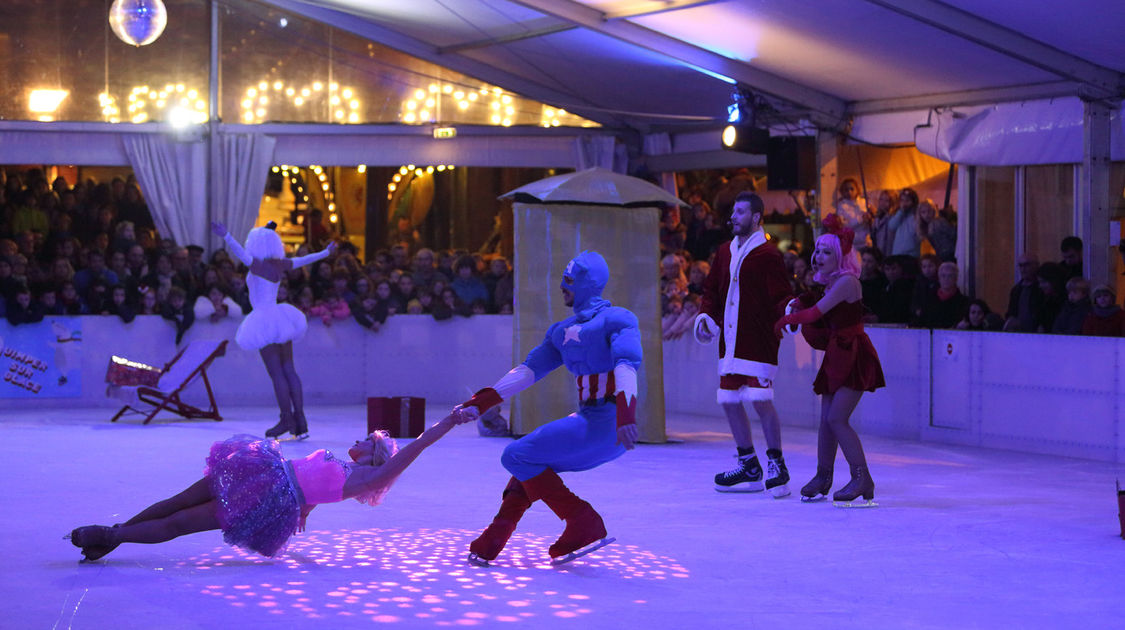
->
[0, 405, 1125, 630]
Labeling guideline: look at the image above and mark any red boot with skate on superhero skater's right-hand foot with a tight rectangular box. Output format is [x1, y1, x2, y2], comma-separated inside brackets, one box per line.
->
[523, 468, 617, 565]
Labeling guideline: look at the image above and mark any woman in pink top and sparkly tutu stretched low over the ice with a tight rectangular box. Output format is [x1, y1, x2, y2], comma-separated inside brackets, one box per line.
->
[70, 414, 468, 560]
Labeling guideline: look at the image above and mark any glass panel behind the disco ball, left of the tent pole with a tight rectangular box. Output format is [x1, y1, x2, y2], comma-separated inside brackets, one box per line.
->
[0, 0, 209, 123]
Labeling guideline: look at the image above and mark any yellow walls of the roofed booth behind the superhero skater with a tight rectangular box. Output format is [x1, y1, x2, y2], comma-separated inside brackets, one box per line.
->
[512, 204, 665, 442]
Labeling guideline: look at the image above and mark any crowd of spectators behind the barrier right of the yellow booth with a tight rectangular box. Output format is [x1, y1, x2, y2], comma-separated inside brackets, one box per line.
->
[659, 179, 1125, 340]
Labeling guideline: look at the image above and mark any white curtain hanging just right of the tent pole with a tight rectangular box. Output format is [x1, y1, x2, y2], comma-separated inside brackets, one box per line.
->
[215, 134, 277, 241]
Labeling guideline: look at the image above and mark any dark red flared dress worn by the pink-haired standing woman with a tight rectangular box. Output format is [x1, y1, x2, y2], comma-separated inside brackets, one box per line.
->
[812, 302, 887, 395]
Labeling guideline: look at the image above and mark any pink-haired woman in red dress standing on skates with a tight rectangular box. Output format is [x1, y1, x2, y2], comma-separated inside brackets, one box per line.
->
[774, 215, 887, 507]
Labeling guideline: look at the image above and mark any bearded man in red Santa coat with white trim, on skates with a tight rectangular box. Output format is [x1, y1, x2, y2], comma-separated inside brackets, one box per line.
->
[694, 192, 793, 498]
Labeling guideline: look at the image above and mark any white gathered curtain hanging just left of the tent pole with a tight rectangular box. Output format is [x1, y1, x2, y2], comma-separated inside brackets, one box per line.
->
[122, 134, 207, 245]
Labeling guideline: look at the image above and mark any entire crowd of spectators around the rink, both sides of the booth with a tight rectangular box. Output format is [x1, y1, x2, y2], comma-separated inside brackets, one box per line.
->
[0, 169, 1125, 339]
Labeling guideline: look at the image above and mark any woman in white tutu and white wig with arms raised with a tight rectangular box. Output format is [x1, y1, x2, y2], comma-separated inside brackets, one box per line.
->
[212, 222, 336, 440]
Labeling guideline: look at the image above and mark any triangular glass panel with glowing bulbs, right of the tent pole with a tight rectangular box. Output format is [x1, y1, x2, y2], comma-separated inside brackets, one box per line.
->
[222, 1, 597, 127]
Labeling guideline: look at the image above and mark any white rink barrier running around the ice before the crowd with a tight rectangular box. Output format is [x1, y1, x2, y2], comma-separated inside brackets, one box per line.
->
[0, 315, 1125, 462]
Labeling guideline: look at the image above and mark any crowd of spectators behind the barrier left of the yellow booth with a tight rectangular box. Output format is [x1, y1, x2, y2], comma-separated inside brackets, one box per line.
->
[0, 169, 513, 340]
